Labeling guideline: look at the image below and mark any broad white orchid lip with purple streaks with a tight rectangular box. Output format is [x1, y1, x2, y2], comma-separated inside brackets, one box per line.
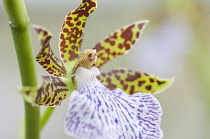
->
[64, 67, 163, 139]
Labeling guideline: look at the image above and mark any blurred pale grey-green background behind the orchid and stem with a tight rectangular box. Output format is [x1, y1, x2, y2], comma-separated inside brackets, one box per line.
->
[0, 0, 210, 139]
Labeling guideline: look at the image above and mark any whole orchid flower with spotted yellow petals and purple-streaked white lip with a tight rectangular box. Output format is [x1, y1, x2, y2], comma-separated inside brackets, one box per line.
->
[19, 0, 172, 139]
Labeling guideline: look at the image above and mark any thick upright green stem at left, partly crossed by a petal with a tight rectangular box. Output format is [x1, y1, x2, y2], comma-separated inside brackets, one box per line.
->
[3, 0, 40, 139]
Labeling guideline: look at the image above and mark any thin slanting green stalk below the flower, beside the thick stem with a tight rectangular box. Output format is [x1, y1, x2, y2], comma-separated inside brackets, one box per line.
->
[40, 107, 55, 130]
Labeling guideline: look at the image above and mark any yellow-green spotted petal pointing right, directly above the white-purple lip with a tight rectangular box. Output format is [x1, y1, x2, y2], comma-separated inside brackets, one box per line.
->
[98, 68, 173, 94]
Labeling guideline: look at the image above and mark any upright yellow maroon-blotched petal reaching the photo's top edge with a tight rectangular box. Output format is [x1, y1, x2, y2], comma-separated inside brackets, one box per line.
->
[60, 0, 97, 69]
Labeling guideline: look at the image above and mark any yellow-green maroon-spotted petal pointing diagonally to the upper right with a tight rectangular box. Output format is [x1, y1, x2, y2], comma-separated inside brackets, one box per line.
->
[92, 20, 148, 67]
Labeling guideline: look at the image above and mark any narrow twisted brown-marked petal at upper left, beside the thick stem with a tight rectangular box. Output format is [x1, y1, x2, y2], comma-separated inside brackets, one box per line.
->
[33, 26, 66, 77]
